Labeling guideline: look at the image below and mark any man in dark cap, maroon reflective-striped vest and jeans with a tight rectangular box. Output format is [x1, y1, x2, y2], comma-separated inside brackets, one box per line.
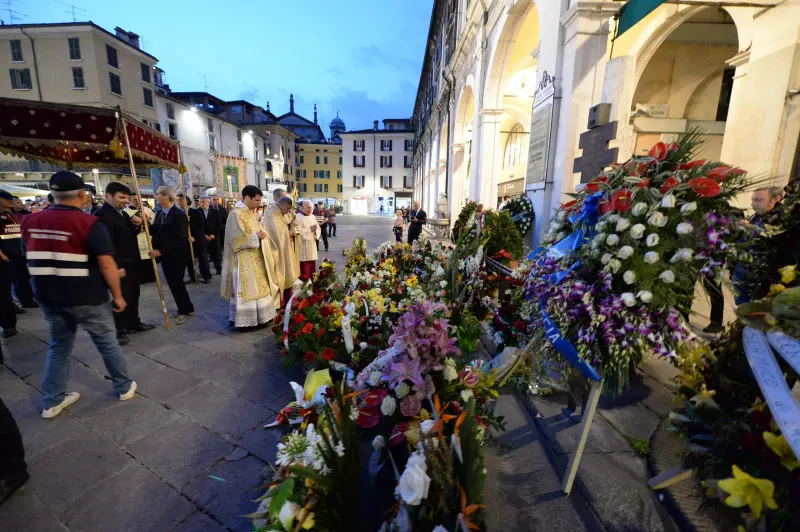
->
[21, 171, 136, 419]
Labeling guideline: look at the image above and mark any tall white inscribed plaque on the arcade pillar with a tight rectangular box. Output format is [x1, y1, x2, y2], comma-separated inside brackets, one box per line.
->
[525, 70, 556, 185]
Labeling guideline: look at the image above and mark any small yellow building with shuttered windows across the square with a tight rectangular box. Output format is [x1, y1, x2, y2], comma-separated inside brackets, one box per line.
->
[295, 142, 342, 204]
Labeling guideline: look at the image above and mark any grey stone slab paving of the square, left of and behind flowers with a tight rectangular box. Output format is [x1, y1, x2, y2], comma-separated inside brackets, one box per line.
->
[0, 216, 392, 532]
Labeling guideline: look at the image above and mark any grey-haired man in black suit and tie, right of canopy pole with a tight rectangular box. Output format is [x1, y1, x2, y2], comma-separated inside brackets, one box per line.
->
[150, 187, 194, 325]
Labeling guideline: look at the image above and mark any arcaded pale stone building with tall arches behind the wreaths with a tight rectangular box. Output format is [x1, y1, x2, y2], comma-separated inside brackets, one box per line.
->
[413, 0, 800, 244]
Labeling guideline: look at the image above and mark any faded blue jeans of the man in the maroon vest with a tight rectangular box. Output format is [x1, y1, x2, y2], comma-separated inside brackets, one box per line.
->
[42, 302, 131, 409]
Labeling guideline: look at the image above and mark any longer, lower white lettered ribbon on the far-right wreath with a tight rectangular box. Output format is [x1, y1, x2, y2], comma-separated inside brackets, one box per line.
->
[743, 327, 800, 456]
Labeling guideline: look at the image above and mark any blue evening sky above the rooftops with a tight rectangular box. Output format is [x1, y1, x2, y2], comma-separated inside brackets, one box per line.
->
[12, 0, 433, 135]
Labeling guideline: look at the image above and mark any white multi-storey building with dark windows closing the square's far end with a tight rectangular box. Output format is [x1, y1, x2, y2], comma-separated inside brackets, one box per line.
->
[340, 119, 414, 215]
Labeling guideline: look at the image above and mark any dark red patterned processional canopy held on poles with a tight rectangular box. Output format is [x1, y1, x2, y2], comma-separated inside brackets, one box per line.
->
[0, 98, 180, 168]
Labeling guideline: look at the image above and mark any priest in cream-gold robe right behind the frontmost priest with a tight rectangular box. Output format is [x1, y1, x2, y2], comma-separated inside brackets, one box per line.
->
[264, 196, 300, 306]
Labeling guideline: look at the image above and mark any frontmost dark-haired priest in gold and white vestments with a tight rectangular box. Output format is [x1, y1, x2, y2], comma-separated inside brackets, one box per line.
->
[220, 185, 280, 329]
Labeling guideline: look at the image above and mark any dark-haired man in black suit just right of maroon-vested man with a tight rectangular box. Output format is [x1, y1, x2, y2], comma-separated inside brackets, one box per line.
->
[94, 181, 155, 345]
